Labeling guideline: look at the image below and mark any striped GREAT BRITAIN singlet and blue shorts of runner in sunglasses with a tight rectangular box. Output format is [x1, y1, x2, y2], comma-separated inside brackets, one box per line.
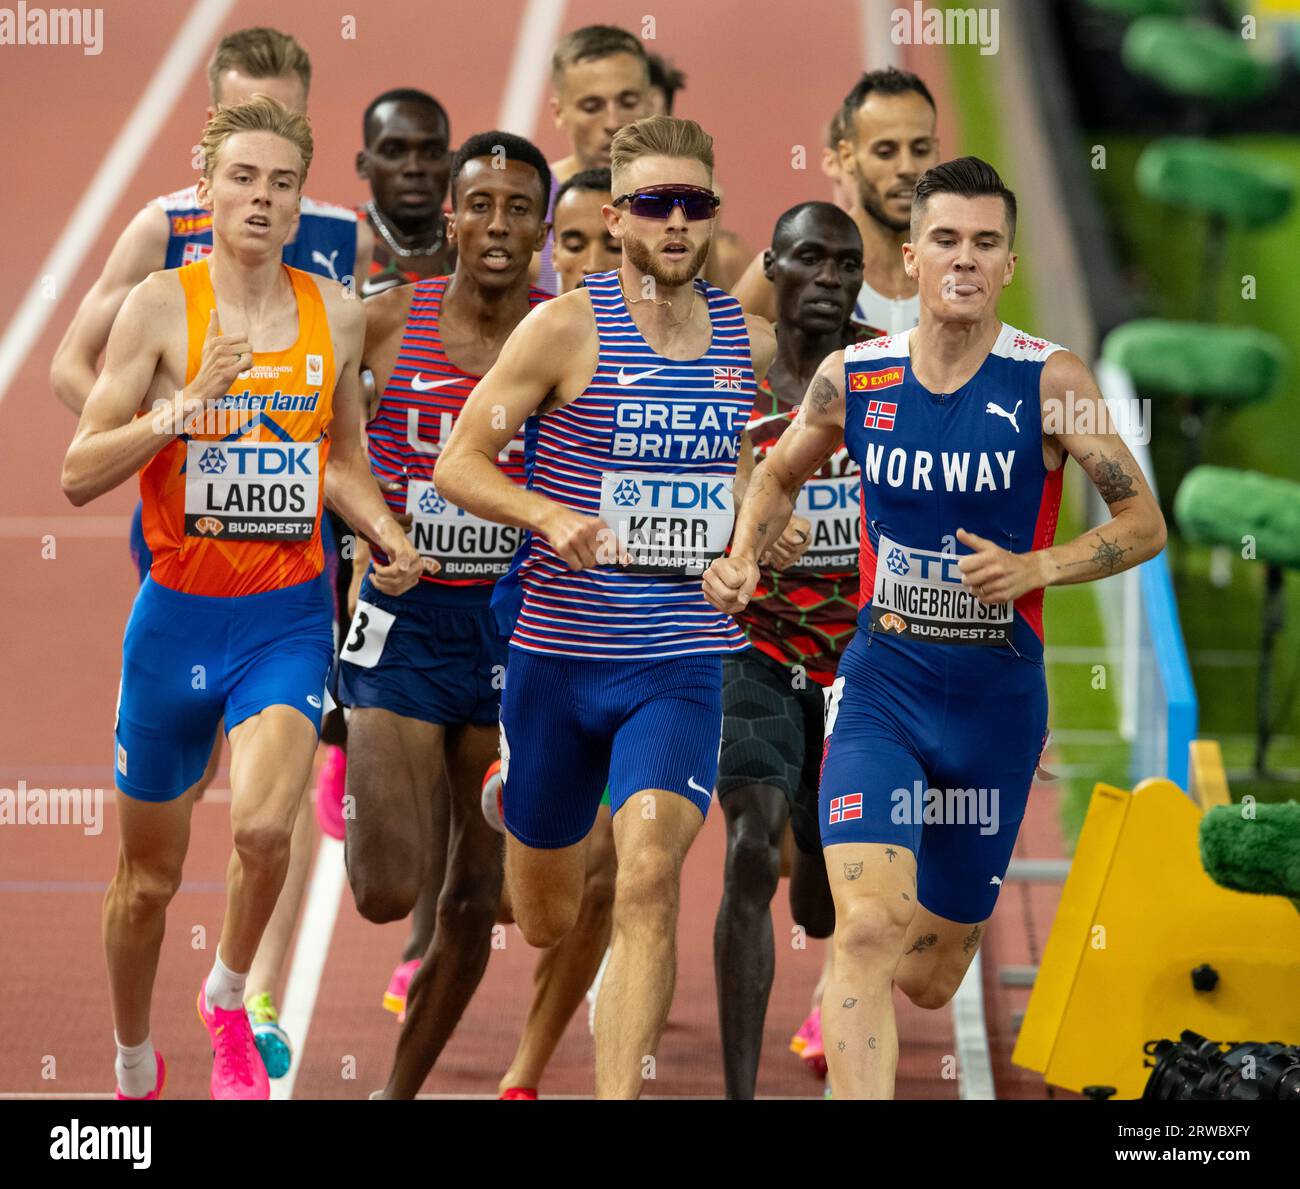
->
[502, 272, 755, 847]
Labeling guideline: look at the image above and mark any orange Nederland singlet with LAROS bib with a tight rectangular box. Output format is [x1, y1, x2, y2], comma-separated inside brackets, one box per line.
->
[140, 259, 334, 598]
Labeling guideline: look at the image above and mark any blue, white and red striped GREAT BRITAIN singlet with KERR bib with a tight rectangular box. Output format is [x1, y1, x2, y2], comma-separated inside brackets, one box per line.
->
[511, 272, 755, 661]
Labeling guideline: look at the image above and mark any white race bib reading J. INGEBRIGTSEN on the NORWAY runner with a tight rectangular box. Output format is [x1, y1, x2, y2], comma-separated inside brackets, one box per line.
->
[871, 533, 1014, 645]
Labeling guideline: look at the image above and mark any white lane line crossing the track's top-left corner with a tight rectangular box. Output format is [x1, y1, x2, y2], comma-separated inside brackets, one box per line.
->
[0, 0, 235, 402]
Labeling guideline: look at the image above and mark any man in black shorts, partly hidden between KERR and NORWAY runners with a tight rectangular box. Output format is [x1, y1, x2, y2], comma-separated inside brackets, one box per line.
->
[714, 203, 862, 1098]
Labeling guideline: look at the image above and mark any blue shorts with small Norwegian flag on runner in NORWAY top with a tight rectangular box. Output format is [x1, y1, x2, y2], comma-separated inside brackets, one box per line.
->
[819, 632, 1048, 924]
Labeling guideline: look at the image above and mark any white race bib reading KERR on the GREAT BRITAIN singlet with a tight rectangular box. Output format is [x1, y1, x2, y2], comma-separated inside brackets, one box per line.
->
[601, 470, 736, 574]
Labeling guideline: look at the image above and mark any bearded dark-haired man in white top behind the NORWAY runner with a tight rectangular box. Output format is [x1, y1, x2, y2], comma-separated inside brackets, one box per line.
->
[736, 66, 939, 339]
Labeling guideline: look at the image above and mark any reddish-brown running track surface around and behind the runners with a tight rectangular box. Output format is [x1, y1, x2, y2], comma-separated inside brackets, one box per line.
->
[0, 0, 1060, 1098]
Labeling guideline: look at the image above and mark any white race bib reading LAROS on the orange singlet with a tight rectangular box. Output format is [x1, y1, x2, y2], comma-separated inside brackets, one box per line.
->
[185, 442, 320, 541]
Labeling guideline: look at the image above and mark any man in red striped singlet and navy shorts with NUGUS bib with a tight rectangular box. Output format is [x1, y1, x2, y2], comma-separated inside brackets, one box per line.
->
[337, 131, 550, 1098]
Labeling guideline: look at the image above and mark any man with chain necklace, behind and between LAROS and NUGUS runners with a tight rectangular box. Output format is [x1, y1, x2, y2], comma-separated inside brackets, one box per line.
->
[356, 87, 452, 298]
